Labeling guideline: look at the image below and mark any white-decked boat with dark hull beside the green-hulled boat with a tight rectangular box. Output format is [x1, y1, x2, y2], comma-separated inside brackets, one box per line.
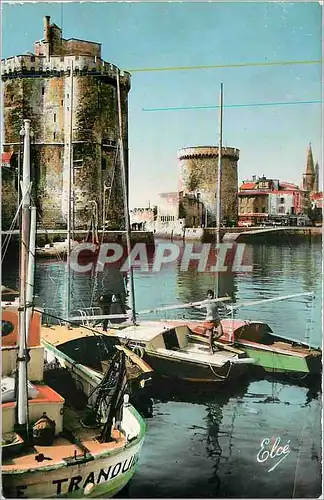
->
[107, 321, 254, 383]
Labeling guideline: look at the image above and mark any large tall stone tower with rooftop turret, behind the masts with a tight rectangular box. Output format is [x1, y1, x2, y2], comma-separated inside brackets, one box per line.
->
[2, 16, 130, 228]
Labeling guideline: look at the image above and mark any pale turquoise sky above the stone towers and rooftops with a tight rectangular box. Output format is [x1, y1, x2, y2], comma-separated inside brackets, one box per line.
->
[1, 2, 323, 208]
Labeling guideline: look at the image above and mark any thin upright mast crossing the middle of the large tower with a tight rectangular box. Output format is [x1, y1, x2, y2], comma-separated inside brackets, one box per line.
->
[66, 60, 73, 318]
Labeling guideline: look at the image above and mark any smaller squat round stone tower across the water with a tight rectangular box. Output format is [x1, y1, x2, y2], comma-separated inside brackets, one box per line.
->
[178, 146, 240, 224]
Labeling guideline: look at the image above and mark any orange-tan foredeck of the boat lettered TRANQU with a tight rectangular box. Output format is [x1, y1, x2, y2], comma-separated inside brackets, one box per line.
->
[2, 408, 125, 472]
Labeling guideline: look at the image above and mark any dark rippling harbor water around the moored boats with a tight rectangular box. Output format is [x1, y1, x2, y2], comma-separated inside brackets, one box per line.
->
[3, 239, 322, 498]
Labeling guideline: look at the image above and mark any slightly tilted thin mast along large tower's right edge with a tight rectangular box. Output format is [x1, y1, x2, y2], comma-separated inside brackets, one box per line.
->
[117, 68, 136, 324]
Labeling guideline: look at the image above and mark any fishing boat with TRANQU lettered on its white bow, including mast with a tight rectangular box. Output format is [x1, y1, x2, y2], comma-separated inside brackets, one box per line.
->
[1, 120, 145, 498]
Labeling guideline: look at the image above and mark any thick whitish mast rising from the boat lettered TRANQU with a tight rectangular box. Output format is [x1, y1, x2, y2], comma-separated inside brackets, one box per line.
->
[17, 120, 30, 435]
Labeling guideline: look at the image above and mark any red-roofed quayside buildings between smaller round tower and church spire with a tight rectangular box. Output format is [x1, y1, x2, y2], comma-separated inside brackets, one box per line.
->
[238, 175, 306, 224]
